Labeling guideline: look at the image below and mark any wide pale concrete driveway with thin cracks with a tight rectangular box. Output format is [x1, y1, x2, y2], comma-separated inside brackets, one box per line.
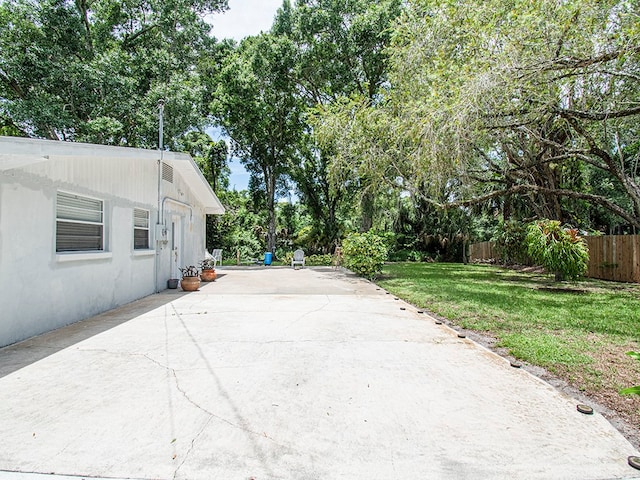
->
[0, 267, 640, 480]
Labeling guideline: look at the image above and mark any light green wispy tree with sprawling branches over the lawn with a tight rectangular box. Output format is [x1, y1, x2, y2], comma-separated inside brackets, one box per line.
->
[317, 0, 640, 231]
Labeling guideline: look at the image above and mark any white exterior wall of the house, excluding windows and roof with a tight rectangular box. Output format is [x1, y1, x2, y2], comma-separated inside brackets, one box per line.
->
[0, 140, 214, 346]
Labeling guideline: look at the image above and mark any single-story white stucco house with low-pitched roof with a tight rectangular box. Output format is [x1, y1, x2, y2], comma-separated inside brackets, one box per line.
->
[0, 137, 224, 346]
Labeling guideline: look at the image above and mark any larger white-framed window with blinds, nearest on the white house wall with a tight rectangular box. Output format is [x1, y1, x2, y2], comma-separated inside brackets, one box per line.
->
[56, 192, 104, 252]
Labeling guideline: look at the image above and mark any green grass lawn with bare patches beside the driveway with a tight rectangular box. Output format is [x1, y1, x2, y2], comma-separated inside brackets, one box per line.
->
[376, 263, 640, 442]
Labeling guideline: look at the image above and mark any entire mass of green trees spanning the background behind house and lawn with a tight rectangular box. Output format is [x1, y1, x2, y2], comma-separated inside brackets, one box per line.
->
[0, 0, 640, 259]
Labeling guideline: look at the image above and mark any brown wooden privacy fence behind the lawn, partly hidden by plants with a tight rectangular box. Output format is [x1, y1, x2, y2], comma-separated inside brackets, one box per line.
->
[469, 235, 640, 283]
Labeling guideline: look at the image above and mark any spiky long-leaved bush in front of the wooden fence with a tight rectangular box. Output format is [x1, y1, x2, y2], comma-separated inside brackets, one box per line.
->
[526, 220, 589, 281]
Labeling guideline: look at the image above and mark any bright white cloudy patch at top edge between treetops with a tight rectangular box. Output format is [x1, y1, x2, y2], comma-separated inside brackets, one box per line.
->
[207, 0, 282, 41]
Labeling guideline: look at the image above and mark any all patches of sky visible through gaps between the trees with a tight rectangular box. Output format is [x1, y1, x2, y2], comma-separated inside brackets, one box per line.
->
[207, 0, 282, 190]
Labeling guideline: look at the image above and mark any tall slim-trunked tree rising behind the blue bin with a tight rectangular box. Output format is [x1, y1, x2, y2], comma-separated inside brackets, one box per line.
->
[210, 34, 304, 253]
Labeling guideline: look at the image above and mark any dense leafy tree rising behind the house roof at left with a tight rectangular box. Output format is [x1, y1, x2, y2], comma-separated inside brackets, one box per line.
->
[0, 0, 227, 147]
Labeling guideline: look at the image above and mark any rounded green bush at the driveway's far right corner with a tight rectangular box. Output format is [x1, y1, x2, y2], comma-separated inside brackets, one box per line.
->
[342, 231, 387, 279]
